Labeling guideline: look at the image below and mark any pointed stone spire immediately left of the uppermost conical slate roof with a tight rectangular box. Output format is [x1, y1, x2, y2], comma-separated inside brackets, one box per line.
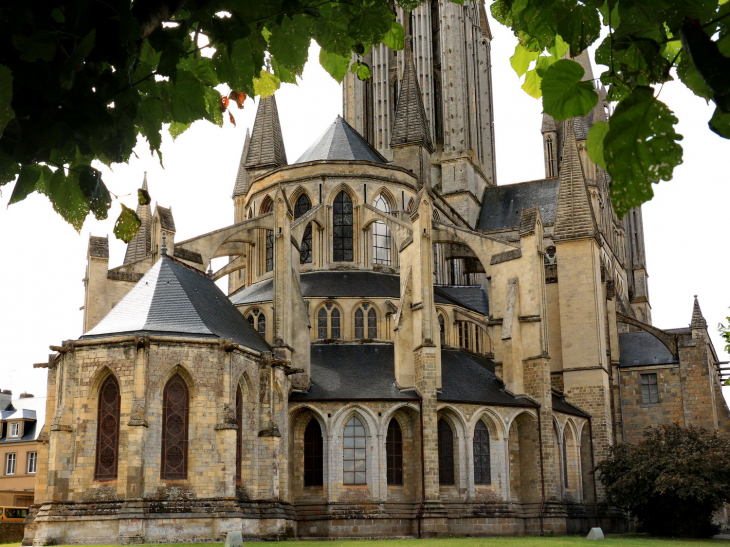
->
[244, 95, 288, 169]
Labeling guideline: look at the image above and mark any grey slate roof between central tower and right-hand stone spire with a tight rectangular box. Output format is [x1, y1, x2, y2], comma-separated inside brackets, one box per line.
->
[477, 178, 559, 232]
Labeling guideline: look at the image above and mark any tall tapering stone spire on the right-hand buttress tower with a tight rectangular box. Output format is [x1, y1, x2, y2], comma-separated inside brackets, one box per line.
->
[553, 120, 598, 241]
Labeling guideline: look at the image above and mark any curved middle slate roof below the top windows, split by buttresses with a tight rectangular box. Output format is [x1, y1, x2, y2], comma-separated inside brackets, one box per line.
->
[231, 271, 489, 315]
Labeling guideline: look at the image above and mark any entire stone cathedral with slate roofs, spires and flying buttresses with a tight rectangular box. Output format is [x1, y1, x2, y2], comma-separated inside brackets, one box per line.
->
[24, 0, 730, 545]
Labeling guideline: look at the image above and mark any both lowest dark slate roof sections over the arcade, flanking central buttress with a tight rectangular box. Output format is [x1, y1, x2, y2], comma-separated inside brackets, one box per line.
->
[289, 344, 534, 406]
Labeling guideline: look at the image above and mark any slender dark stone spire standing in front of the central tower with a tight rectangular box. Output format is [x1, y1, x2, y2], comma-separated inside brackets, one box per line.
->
[390, 36, 434, 153]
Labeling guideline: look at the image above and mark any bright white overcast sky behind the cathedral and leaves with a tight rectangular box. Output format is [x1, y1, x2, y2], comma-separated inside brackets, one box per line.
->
[0, 10, 730, 406]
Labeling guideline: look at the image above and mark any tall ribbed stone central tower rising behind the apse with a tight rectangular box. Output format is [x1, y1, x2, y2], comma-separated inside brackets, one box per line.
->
[343, 0, 496, 226]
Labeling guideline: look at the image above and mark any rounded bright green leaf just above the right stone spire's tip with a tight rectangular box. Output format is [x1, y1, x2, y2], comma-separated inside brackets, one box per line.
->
[542, 59, 598, 121]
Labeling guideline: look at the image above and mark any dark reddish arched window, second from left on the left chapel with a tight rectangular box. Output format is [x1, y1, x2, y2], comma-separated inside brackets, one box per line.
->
[160, 374, 189, 480]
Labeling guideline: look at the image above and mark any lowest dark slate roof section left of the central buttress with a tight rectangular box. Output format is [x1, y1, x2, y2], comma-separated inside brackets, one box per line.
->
[289, 344, 418, 401]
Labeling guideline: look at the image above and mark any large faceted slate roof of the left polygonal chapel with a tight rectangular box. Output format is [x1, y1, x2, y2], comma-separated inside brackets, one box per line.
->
[81, 255, 271, 351]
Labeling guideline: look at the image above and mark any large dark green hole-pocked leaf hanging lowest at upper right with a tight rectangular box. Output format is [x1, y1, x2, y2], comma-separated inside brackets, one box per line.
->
[603, 86, 682, 217]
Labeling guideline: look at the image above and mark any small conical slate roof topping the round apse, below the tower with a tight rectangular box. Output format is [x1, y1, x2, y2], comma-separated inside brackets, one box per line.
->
[295, 115, 386, 163]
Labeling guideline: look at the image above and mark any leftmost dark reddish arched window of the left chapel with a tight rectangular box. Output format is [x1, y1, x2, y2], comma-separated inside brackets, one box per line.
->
[94, 375, 121, 481]
